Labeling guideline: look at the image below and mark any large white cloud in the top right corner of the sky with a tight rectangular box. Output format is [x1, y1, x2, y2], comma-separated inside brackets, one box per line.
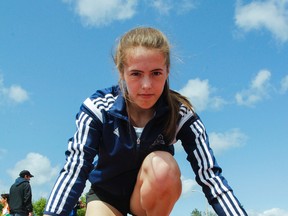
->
[235, 0, 288, 42]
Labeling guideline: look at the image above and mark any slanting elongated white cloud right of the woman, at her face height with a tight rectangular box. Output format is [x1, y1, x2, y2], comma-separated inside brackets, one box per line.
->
[235, 70, 271, 106]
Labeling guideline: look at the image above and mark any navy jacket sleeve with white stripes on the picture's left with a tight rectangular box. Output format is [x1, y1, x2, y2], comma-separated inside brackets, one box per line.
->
[44, 105, 102, 215]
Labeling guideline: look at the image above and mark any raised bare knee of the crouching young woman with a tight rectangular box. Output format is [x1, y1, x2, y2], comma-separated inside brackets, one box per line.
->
[130, 151, 182, 216]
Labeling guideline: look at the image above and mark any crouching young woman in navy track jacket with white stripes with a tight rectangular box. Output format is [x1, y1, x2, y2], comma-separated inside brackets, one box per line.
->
[45, 27, 247, 216]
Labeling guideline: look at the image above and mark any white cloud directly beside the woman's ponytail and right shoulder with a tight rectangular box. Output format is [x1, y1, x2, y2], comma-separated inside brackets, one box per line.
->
[179, 78, 226, 112]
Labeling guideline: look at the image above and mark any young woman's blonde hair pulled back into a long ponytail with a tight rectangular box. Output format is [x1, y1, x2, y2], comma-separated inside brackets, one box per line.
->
[114, 27, 193, 144]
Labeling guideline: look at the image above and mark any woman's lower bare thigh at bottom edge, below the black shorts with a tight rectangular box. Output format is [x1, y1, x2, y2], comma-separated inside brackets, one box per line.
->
[85, 200, 122, 216]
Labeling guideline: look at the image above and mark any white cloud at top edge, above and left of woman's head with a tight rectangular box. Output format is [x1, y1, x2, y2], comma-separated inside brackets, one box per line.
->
[64, 0, 138, 26]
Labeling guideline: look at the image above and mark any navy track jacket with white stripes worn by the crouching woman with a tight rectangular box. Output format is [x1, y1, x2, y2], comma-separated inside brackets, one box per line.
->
[44, 86, 247, 215]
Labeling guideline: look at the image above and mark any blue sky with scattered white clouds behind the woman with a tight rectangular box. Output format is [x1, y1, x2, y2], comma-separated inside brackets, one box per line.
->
[0, 0, 288, 216]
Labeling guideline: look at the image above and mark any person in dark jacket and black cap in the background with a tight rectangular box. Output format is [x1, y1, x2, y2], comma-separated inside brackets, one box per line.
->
[9, 170, 34, 216]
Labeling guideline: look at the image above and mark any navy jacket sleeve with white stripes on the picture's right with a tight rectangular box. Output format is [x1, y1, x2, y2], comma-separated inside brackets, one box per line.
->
[177, 112, 247, 216]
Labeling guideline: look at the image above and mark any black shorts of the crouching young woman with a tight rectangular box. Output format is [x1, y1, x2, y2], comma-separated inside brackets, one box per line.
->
[86, 185, 131, 215]
